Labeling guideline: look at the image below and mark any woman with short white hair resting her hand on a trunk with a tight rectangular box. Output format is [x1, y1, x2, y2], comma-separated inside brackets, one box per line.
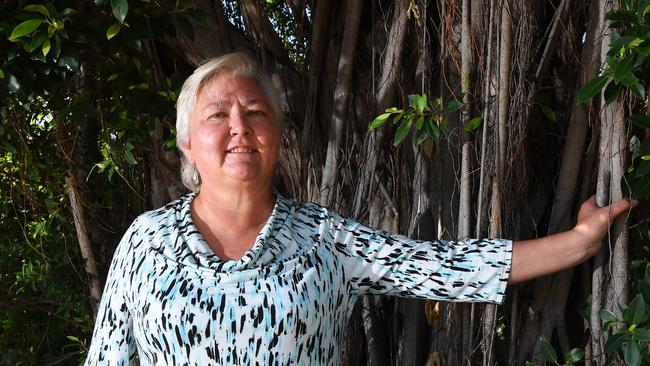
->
[86, 54, 630, 365]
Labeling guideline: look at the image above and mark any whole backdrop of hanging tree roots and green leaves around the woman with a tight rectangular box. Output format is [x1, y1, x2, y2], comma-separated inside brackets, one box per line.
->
[0, 0, 650, 365]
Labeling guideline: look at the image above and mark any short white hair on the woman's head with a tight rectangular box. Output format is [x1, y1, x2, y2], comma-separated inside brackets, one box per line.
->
[176, 52, 283, 191]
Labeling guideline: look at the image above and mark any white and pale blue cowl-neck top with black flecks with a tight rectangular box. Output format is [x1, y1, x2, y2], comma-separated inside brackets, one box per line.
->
[86, 193, 512, 365]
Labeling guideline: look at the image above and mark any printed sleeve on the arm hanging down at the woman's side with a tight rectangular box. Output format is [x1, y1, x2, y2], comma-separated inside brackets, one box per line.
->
[86, 221, 137, 366]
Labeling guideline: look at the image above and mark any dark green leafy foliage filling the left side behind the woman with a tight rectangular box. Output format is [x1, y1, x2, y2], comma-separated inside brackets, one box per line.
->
[0, 0, 195, 364]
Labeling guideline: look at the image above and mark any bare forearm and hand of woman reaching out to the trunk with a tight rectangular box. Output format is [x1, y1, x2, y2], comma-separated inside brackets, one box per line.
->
[508, 196, 636, 284]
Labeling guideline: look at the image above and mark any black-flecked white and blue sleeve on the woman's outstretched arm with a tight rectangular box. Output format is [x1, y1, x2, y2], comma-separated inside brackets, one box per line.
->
[330, 212, 512, 303]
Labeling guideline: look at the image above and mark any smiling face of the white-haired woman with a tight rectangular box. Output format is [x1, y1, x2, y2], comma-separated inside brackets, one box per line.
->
[184, 73, 280, 187]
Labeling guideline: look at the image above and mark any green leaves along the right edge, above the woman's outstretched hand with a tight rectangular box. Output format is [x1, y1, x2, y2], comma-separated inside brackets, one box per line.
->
[577, 0, 650, 198]
